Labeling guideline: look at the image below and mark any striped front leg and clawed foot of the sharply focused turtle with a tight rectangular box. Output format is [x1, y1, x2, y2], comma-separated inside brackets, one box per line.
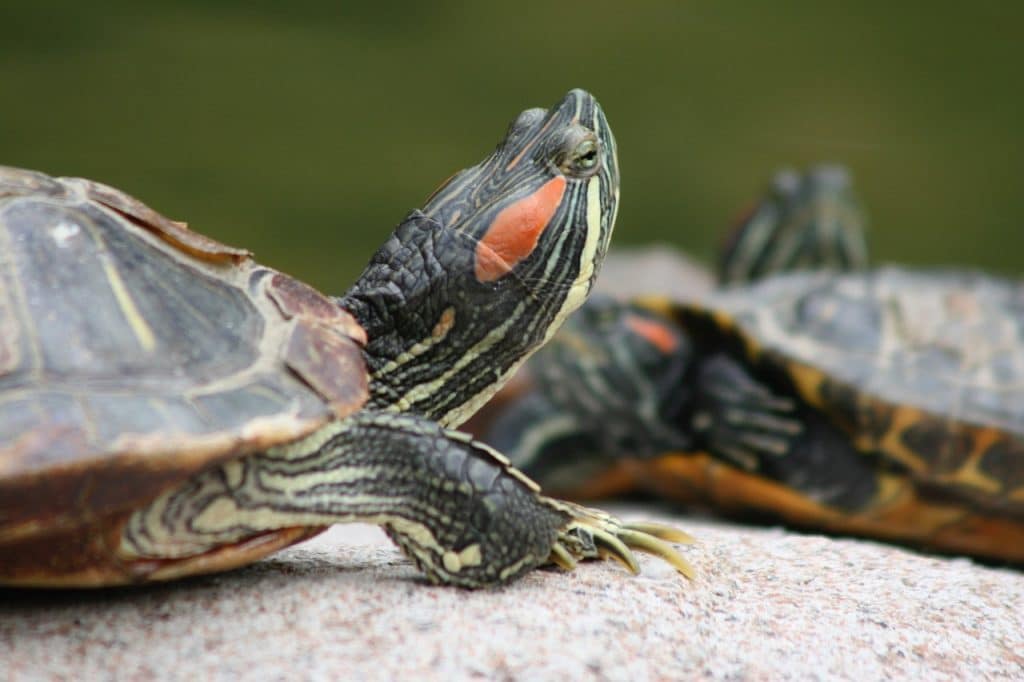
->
[121, 411, 689, 588]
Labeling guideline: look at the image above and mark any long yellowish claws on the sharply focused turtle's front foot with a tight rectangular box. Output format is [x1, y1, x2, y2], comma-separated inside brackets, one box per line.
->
[549, 502, 694, 580]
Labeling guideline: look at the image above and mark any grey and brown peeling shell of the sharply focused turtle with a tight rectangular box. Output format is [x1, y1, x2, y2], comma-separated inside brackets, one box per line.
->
[0, 167, 367, 582]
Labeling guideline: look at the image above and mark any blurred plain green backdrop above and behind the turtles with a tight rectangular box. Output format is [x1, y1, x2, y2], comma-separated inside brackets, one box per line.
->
[0, 0, 1024, 293]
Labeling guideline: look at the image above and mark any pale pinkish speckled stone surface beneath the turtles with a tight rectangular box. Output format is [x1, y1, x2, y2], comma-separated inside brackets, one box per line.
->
[6, 507, 1024, 680]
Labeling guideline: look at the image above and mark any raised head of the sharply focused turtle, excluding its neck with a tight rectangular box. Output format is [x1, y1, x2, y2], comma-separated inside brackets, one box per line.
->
[423, 84, 618, 292]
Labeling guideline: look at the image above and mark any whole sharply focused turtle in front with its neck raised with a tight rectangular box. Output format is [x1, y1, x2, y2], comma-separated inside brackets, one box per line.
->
[0, 89, 691, 588]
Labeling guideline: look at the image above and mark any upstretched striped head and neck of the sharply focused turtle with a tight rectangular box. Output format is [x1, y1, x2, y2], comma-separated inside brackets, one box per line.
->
[340, 90, 618, 426]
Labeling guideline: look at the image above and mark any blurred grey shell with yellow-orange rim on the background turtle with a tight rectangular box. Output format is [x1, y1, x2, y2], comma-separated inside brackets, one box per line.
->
[675, 267, 1024, 517]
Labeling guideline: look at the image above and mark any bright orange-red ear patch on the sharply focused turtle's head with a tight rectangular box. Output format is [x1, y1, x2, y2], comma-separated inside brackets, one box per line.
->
[475, 176, 565, 282]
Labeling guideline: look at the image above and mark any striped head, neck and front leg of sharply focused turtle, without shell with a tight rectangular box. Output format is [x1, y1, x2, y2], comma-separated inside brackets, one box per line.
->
[108, 90, 689, 587]
